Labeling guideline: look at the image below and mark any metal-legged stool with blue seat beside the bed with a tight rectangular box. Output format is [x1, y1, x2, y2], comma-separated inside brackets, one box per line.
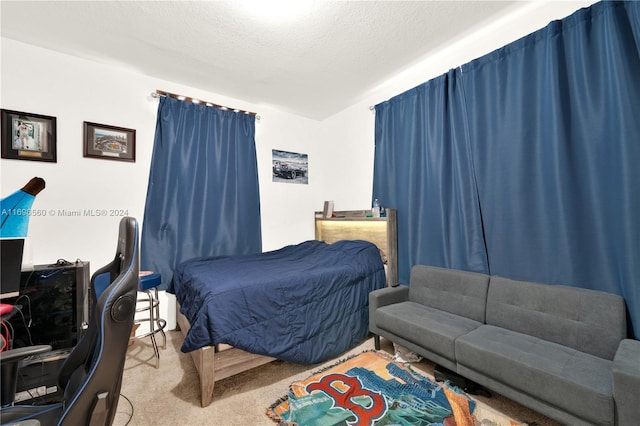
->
[131, 271, 167, 368]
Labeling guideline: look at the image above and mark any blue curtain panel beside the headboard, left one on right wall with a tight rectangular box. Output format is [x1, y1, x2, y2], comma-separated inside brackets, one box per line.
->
[373, 71, 488, 283]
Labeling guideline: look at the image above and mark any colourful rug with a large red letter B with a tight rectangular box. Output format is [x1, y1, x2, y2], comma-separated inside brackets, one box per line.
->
[267, 351, 520, 426]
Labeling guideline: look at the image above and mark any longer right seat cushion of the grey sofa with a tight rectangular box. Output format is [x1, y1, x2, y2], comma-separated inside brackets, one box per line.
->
[455, 325, 614, 424]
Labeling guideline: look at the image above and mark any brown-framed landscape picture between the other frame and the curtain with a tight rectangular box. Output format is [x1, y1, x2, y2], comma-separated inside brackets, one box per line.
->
[83, 121, 136, 162]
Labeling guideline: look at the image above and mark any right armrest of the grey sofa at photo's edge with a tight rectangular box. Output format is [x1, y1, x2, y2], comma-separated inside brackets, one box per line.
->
[612, 339, 640, 425]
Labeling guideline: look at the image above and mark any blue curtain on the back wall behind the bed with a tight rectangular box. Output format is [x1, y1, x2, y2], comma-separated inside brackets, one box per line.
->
[140, 96, 262, 288]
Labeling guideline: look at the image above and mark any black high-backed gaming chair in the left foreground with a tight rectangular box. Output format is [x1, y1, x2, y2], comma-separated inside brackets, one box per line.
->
[0, 217, 140, 426]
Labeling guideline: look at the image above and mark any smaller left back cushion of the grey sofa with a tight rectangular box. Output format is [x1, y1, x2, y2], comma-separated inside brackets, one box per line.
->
[409, 265, 489, 322]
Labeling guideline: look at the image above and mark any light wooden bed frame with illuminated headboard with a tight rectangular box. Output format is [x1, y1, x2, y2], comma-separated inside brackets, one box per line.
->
[176, 209, 398, 407]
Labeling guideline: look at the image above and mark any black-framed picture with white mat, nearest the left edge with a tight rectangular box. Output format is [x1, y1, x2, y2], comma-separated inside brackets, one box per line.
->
[0, 109, 56, 163]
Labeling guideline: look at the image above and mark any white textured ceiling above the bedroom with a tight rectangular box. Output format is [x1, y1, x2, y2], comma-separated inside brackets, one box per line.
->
[0, 0, 518, 120]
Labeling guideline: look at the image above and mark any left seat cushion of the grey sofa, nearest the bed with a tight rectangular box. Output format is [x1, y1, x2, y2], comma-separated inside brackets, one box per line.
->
[374, 301, 482, 363]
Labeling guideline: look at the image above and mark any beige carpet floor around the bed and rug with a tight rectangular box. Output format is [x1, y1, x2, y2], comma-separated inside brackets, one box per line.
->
[114, 330, 559, 426]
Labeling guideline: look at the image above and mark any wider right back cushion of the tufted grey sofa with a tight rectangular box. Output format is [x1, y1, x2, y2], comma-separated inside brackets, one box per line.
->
[486, 276, 627, 360]
